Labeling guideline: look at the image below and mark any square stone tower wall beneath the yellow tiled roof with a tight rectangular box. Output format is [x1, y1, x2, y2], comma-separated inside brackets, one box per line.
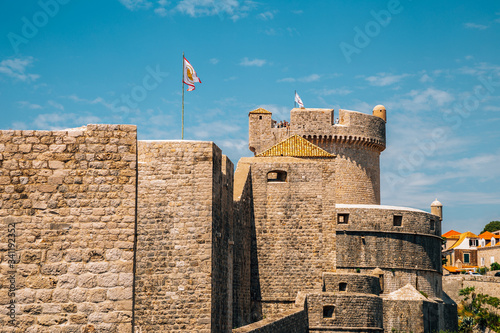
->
[240, 157, 336, 315]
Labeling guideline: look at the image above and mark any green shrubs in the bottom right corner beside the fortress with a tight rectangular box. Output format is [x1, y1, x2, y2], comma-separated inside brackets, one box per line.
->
[458, 287, 500, 333]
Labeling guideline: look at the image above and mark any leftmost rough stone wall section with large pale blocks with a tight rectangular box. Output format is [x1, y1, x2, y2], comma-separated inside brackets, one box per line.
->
[0, 125, 136, 332]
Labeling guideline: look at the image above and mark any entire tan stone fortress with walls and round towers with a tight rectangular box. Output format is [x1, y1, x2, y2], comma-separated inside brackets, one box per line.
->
[0, 105, 457, 333]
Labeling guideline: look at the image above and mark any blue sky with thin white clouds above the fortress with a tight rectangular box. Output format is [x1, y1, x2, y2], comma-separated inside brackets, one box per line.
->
[0, 0, 500, 233]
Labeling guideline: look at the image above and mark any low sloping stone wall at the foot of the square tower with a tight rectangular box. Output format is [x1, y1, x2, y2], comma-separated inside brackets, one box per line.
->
[233, 308, 309, 333]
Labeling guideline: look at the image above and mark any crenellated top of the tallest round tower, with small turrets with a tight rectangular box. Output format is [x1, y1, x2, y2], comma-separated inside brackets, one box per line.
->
[249, 108, 386, 154]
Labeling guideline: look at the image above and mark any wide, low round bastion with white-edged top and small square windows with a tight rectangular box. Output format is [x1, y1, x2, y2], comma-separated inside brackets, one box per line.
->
[336, 204, 441, 297]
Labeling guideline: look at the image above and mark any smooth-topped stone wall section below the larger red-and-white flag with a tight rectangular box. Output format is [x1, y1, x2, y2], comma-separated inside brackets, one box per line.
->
[135, 141, 232, 332]
